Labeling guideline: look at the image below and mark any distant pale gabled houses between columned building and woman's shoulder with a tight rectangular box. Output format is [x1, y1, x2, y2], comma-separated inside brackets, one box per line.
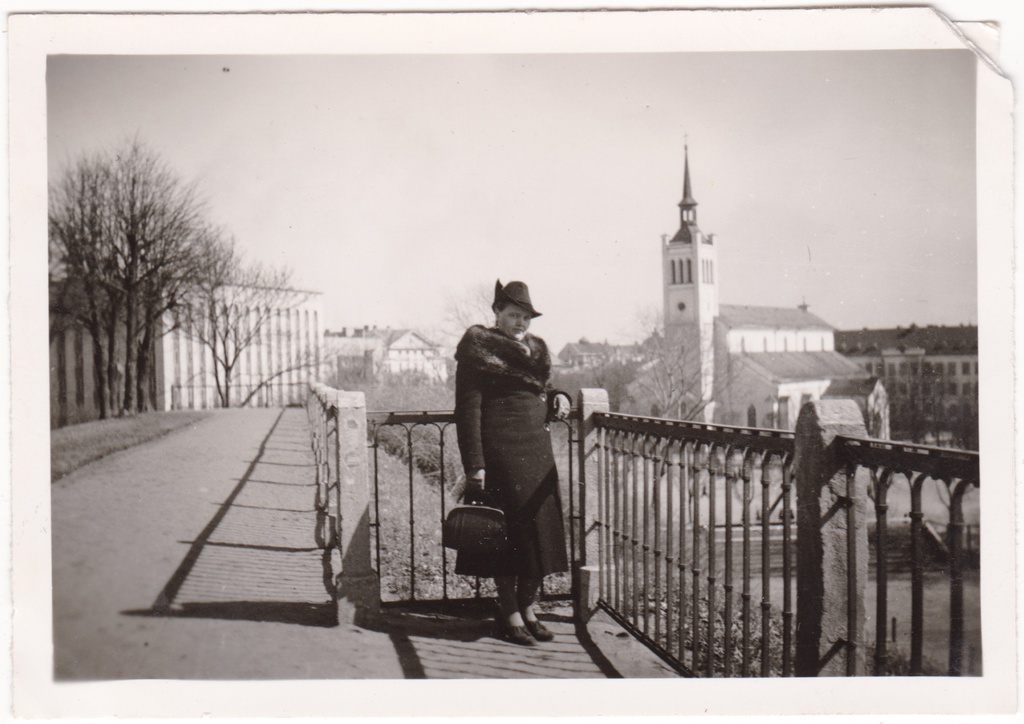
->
[324, 327, 449, 382]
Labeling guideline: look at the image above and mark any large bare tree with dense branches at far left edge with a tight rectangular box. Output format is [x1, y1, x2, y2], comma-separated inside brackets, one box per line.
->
[49, 139, 209, 417]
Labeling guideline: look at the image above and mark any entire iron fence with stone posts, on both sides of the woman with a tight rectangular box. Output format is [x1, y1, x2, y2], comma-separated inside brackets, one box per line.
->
[307, 384, 980, 676]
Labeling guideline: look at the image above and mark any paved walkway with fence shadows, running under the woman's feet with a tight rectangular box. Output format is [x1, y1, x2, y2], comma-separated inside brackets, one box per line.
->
[52, 409, 672, 681]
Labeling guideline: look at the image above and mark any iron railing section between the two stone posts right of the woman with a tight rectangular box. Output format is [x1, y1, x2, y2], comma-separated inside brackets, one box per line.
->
[595, 413, 795, 676]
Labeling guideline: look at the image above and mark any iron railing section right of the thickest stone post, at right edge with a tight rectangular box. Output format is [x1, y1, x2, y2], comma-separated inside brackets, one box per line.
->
[836, 436, 980, 676]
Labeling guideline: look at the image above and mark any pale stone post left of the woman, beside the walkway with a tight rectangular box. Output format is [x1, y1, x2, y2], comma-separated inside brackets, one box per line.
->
[332, 391, 380, 625]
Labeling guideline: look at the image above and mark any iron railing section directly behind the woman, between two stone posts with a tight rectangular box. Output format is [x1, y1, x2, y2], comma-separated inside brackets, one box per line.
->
[367, 412, 580, 605]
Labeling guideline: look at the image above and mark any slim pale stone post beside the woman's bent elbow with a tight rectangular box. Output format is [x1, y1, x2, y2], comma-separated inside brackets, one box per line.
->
[572, 389, 608, 623]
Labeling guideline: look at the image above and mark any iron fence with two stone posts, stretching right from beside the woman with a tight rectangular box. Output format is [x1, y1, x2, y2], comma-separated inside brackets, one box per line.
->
[580, 390, 980, 676]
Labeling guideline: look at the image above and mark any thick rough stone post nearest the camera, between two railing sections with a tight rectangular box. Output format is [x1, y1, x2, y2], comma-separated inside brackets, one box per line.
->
[795, 399, 867, 676]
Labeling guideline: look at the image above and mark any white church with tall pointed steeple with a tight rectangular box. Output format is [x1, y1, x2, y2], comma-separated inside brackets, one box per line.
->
[649, 147, 888, 437]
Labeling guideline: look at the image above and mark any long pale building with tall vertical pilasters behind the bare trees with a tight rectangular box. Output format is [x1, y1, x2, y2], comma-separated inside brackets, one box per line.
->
[50, 289, 322, 427]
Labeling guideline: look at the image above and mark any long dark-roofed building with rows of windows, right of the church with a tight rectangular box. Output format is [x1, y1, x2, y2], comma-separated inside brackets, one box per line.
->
[836, 325, 978, 450]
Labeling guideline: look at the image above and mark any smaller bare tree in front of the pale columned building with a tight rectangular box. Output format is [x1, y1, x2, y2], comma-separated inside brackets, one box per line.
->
[183, 236, 319, 408]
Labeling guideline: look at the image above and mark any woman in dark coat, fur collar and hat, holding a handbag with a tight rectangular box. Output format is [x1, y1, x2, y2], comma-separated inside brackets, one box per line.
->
[455, 281, 570, 646]
